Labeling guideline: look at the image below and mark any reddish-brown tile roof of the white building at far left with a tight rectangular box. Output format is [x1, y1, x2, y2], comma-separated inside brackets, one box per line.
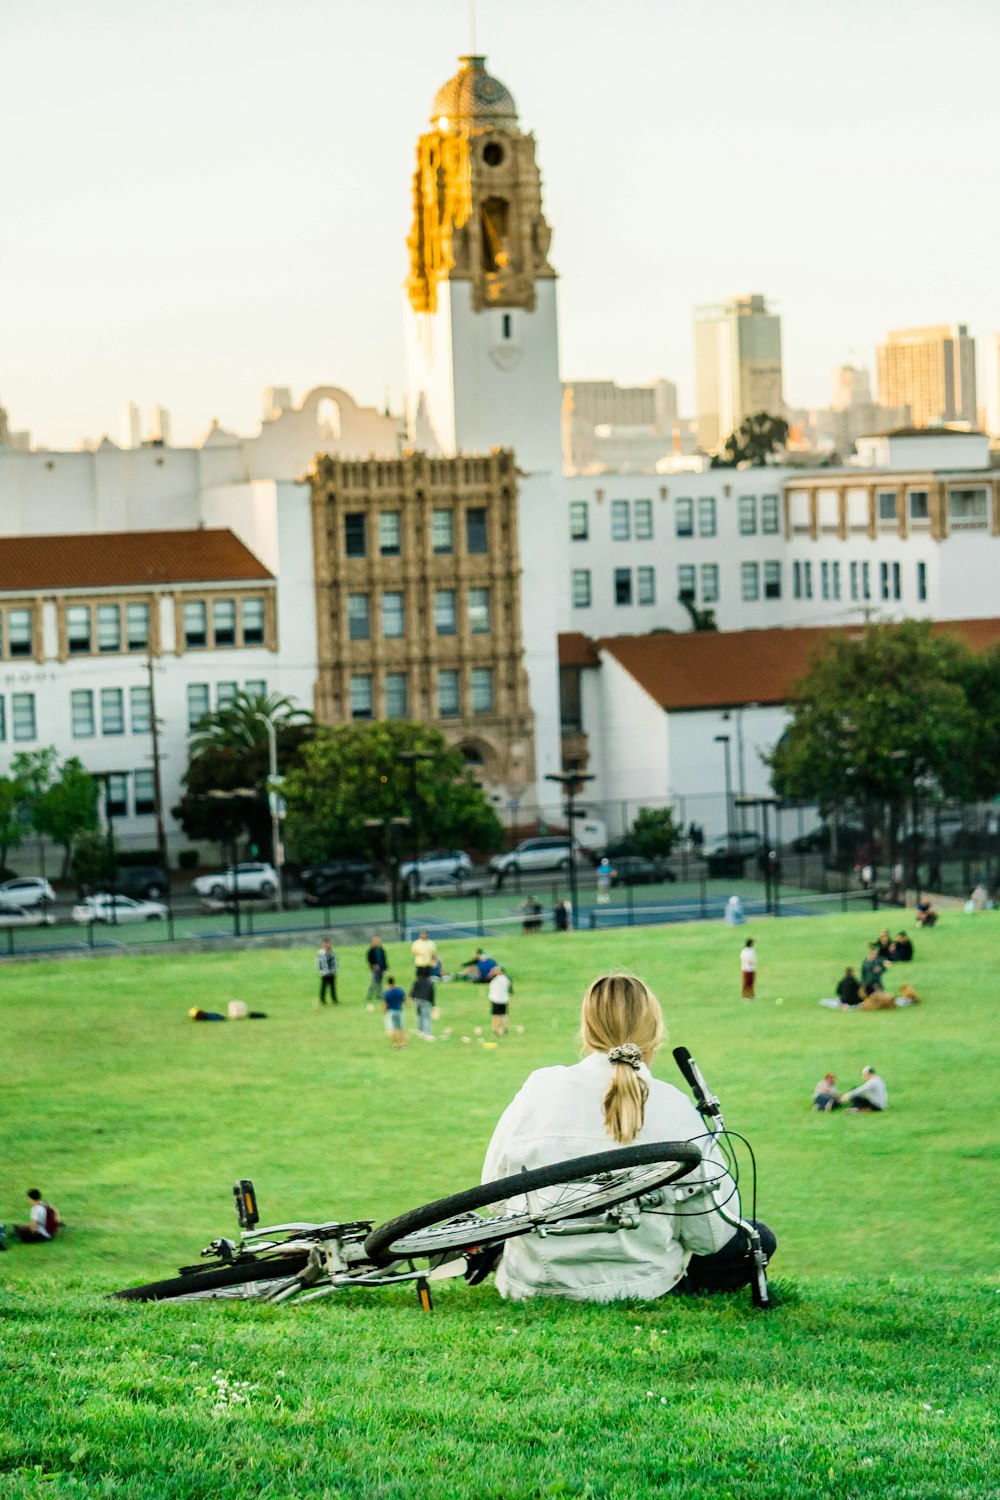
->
[0, 530, 273, 591]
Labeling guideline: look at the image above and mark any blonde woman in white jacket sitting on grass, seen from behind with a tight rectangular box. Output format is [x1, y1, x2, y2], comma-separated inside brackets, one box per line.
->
[483, 974, 775, 1302]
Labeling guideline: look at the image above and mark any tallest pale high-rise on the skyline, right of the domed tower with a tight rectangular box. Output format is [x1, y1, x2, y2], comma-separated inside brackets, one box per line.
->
[694, 293, 784, 453]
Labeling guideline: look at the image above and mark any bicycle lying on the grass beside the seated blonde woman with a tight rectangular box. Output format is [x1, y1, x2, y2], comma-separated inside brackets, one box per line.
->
[114, 1047, 769, 1311]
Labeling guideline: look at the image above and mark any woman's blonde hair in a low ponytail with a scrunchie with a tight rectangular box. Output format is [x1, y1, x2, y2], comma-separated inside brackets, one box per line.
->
[580, 974, 664, 1146]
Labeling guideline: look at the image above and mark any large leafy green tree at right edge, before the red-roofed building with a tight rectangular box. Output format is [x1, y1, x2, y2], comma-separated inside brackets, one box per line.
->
[768, 620, 1000, 836]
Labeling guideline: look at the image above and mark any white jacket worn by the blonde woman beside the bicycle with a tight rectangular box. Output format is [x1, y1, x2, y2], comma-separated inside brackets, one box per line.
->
[483, 1053, 739, 1302]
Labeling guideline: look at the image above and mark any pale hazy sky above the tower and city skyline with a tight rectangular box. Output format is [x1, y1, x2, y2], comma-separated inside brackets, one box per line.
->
[0, 0, 1000, 447]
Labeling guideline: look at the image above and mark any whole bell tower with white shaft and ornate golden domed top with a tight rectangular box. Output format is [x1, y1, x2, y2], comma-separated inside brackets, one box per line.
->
[406, 56, 562, 473]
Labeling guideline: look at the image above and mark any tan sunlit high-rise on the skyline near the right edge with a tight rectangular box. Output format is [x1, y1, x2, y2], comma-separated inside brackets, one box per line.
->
[876, 323, 976, 428]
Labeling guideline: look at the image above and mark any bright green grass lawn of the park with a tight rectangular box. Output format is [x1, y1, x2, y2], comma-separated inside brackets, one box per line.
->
[0, 914, 1000, 1500]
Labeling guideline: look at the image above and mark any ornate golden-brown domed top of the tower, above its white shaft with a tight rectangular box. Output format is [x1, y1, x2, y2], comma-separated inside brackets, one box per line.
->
[406, 57, 555, 314]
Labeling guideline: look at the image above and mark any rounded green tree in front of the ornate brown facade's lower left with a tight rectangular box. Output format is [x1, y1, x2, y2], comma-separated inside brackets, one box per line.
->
[283, 720, 502, 864]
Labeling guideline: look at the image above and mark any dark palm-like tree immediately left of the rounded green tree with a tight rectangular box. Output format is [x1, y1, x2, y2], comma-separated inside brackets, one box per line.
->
[172, 693, 316, 857]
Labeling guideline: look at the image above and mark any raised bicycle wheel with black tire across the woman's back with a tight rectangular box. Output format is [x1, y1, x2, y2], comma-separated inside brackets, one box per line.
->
[364, 1140, 702, 1266]
